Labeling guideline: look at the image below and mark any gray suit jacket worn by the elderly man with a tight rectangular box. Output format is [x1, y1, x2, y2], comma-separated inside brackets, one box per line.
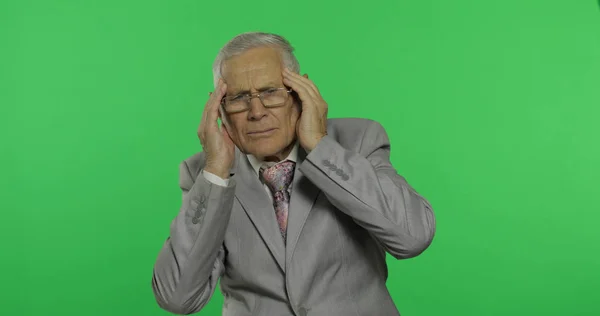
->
[152, 119, 435, 316]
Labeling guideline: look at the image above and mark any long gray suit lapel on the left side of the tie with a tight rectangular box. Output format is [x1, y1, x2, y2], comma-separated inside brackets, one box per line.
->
[231, 148, 285, 271]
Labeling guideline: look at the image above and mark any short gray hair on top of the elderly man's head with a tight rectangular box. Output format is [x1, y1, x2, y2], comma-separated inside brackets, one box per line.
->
[213, 32, 300, 88]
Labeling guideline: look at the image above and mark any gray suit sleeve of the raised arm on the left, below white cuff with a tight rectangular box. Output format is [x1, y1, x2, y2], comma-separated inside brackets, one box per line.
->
[152, 162, 235, 315]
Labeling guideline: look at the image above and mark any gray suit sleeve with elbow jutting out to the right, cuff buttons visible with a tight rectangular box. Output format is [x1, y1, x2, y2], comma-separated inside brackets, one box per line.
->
[300, 121, 435, 259]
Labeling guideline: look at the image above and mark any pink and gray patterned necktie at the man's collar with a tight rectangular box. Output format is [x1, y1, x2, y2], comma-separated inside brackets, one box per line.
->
[260, 160, 296, 241]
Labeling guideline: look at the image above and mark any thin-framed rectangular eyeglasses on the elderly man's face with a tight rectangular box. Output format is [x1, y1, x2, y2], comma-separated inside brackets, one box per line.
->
[221, 88, 292, 114]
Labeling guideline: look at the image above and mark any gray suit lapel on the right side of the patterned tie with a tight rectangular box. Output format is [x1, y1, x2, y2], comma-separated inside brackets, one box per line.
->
[285, 147, 320, 264]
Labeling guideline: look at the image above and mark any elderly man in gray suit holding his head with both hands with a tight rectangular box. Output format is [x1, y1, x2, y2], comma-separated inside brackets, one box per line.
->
[152, 33, 435, 316]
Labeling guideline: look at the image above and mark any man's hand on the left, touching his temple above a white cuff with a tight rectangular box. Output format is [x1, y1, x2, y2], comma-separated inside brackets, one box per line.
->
[198, 79, 235, 179]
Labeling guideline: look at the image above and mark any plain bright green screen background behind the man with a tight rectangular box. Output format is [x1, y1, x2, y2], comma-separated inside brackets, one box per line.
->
[0, 0, 600, 316]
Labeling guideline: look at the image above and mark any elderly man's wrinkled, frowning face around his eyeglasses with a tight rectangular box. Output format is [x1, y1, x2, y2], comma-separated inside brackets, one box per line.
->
[222, 47, 300, 160]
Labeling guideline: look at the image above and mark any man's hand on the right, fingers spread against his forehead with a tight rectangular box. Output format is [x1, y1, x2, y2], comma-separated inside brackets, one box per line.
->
[283, 68, 327, 152]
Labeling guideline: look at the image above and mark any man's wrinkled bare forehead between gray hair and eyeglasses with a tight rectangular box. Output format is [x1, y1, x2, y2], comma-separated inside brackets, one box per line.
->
[223, 47, 282, 88]
